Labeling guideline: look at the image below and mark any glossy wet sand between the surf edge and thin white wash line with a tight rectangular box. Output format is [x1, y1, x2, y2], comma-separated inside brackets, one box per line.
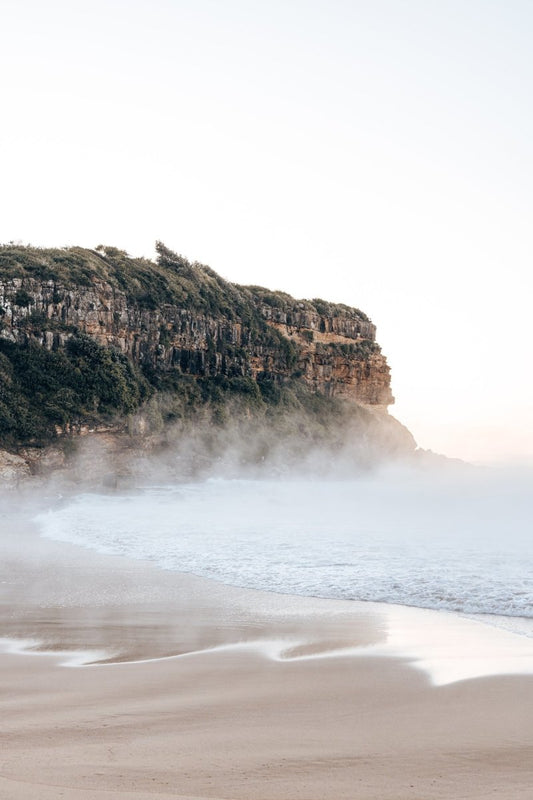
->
[0, 506, 533, 683]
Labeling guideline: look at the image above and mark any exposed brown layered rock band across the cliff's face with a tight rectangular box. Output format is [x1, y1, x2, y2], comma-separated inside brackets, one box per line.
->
[0, 276, 394, 407]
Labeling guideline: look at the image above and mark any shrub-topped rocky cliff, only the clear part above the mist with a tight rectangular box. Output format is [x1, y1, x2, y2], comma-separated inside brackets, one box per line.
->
[0, 243, 412, 482]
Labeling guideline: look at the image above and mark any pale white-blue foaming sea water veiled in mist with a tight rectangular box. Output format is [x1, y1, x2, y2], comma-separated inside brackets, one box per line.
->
[37, 466, 533, 617]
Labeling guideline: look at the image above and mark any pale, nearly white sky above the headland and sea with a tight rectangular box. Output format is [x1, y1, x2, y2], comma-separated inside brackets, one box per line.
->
[0, 0, 533, 463]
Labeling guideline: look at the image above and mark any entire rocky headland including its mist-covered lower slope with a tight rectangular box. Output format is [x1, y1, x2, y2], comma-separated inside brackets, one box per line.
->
[0, 242, 415, 479]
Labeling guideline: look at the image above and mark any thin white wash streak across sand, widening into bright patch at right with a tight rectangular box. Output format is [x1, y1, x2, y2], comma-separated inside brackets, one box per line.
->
[0, 601, 533, 686]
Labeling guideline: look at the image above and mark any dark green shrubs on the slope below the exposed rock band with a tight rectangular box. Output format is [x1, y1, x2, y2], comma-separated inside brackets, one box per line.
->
[0, 336, 364, 454]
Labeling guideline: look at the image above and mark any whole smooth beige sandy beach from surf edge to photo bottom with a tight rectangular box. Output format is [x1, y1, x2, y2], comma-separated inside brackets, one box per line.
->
[0, 504, 533, 800]
